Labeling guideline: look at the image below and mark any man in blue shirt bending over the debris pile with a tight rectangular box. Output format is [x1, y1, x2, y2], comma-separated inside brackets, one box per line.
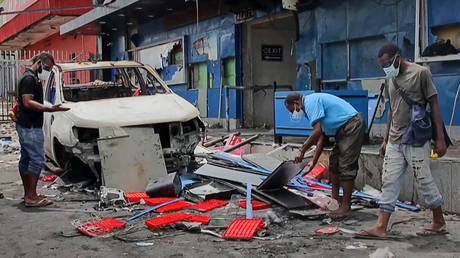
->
[284, 92, 365, 219]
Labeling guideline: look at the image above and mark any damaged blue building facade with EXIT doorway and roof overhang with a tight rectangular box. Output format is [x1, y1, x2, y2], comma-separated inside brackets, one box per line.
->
[60, 0, 460, 138]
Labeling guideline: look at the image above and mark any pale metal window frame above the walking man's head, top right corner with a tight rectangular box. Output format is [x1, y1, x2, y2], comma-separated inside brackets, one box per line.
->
[414, 0, 460, 63]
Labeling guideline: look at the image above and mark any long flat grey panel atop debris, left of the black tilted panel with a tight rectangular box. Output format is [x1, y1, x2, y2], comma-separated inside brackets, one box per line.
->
[195, 164, 263, 186]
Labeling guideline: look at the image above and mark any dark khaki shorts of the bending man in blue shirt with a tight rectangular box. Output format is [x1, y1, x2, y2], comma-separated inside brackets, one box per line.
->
[329, 113, 365, 181]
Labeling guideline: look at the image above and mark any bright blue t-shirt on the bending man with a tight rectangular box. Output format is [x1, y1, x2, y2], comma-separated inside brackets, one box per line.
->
[303, 93, 358, 135]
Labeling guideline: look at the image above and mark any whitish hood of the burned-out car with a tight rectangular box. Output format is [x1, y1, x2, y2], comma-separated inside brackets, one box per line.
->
[63, 93, 200, 128]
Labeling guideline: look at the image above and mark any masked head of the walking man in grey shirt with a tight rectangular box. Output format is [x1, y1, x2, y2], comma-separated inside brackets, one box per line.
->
[378, 43, 403, 77]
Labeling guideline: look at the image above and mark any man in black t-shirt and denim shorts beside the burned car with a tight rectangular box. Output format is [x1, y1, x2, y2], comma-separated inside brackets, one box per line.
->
[16, 53, 69, 207]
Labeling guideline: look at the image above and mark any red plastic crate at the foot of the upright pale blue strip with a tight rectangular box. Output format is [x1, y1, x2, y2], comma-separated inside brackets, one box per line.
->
[222, 219, 264, 240]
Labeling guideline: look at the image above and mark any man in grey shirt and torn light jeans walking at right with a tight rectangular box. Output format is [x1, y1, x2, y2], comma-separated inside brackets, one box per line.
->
[357, 44, 447, 238]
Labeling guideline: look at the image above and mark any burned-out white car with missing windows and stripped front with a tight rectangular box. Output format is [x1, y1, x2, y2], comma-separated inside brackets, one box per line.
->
[43, 61, 204, 183]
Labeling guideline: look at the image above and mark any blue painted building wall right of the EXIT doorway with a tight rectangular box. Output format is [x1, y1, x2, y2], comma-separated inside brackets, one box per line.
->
[296, 0, 460, 125]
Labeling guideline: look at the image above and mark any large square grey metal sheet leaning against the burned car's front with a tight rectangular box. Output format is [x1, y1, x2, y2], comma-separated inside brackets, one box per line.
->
[98, 127, 167, 192]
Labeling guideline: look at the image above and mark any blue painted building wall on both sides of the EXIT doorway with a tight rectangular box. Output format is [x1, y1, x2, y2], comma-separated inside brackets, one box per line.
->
[108, 0, 460, 125]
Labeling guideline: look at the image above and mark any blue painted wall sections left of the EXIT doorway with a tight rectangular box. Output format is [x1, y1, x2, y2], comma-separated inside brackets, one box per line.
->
[111, 15, 242, 118]
